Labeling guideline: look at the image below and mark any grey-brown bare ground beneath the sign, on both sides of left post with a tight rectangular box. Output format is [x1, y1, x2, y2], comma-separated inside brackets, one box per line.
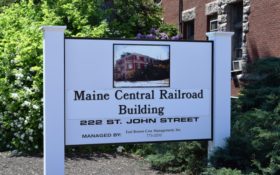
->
[0, 152, 179, 175]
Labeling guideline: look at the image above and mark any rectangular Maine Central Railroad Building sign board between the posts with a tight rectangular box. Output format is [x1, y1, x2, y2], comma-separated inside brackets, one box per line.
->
[65, 38, 213, 145]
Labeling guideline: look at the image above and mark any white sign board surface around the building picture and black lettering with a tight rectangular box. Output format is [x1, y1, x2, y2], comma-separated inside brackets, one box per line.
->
[65, 38, 214, 145]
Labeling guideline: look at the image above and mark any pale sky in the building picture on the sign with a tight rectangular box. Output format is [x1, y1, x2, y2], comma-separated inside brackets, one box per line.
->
[114, 45, 169, 60]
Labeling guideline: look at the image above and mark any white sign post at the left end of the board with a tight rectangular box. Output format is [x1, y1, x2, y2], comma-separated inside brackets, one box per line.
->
[42, 26, 66, 175]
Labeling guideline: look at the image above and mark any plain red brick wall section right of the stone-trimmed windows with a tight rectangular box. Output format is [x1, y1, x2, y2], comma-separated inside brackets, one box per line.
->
[247, 0, 280, 60]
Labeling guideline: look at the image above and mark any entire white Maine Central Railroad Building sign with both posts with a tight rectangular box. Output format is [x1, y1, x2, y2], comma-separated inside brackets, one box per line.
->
[42, 26, 232, 175]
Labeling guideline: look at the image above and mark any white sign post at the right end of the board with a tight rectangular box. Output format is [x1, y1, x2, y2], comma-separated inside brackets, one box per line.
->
[206, 32, 234, 157]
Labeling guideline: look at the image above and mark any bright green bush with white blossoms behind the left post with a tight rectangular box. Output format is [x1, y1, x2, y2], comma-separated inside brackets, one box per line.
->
[0, 1, 109, 152]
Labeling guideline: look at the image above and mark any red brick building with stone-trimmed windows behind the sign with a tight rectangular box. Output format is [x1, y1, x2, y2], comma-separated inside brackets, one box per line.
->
[159, 0, 280, 95]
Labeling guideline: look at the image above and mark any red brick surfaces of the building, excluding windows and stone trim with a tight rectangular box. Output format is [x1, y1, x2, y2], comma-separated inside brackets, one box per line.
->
[162, 0, 280, 61]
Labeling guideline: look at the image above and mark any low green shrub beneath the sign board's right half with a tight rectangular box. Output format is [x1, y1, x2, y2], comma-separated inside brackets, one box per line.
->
[133, 142, 207, 174]
